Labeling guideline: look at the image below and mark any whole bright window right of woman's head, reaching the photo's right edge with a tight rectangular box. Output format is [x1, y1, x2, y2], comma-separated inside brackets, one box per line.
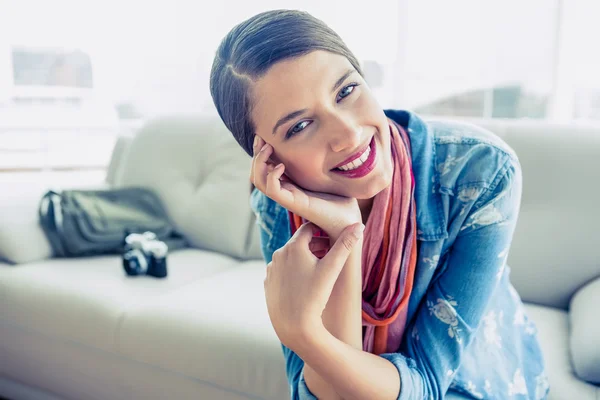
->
[397, 0, 600, 122]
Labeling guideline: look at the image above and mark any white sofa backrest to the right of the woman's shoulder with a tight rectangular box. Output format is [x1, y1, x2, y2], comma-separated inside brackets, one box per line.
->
[471, 120, 600, 309]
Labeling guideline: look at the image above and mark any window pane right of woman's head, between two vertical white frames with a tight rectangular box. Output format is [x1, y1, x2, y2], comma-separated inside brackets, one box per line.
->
[390, 0, 558, 118]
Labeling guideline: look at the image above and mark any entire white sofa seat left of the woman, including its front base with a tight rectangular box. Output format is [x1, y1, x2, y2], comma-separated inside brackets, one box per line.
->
[0, 249, 282, 400]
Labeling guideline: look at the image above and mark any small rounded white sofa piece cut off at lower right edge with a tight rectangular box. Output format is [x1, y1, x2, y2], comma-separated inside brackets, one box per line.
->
[569, 277, 600, 383]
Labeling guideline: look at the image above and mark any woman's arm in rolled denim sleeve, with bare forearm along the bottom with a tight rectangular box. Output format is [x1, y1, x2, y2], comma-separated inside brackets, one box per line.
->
[297, 161, 521, 400]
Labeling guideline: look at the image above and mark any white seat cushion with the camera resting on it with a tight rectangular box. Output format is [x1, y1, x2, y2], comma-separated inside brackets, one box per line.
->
[0, 249, 238, 351]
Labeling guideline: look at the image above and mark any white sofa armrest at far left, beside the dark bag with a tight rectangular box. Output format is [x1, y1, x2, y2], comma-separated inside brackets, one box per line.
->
[0, 182, 108, 264]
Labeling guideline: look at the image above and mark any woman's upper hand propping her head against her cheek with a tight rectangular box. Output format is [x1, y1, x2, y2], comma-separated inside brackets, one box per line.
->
[250, 136, 362, 240]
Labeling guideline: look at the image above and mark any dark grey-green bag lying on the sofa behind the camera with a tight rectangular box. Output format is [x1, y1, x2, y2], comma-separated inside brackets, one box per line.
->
[39, 188, 187, 257]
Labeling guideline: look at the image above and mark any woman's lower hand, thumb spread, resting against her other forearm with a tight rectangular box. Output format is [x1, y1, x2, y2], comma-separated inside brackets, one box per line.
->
[264, 223, 364, 350]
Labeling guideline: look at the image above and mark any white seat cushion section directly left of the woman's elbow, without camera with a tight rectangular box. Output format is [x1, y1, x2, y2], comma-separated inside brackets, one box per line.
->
[119, 261, 289, 400]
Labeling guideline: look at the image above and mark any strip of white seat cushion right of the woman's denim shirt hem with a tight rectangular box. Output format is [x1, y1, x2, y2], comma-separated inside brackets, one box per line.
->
[525, 304, 600, 400]
